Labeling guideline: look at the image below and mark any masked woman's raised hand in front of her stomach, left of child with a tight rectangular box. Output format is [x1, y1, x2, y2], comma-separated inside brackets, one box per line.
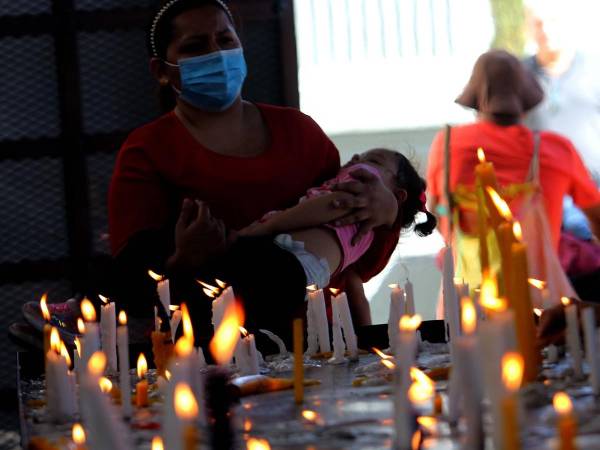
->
[167, 199, 227, 270]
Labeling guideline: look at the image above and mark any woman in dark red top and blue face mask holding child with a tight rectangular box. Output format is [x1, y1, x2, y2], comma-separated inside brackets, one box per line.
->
[109, 0, 399, 342]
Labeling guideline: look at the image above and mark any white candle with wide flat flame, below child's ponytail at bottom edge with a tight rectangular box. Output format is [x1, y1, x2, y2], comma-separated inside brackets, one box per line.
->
[394, 315, 421, 448]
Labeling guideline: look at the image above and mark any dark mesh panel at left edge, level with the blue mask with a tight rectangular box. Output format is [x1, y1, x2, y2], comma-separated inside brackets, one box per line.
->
[0, 36, 60, 141]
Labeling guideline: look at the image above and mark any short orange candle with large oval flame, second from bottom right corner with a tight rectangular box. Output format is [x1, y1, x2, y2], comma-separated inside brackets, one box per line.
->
[494, 352, 524, 450]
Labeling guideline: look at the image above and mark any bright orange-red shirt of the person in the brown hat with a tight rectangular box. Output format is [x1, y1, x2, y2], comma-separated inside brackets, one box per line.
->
[427, 121, 600, 250]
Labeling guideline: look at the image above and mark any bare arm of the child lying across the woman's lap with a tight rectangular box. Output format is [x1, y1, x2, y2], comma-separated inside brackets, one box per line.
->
[239, 192, 352, 236]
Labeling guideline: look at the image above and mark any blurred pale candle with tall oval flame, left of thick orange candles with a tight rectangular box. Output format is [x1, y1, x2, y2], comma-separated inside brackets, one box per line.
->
[452, 297, 484, 449]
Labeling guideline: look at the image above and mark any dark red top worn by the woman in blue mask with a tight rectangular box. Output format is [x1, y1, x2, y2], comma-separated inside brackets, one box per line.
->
[108, 104, 397, 279]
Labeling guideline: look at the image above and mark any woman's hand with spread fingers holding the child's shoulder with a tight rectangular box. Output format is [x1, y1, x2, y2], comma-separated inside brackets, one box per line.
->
[331, 169, 398, 244]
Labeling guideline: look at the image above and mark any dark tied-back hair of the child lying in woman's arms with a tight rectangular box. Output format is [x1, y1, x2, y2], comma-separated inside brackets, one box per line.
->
[388, 150, 437, 236]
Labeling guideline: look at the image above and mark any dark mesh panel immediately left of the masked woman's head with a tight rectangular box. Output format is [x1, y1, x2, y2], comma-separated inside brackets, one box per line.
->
[79, 30, 158, 134]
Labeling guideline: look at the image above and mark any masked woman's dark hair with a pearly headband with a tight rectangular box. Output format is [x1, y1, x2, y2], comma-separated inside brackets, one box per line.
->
[146, 0, 237, 112]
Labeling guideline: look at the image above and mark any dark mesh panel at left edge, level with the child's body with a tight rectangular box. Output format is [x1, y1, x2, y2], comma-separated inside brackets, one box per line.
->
[0, 158, 68, 262]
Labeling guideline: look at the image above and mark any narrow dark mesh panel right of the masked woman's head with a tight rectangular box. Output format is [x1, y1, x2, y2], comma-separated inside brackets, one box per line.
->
[242, 21, 285, 105]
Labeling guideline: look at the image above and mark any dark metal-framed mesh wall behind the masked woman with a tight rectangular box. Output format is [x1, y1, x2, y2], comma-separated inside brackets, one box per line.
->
[0, 0, 298, 429]
